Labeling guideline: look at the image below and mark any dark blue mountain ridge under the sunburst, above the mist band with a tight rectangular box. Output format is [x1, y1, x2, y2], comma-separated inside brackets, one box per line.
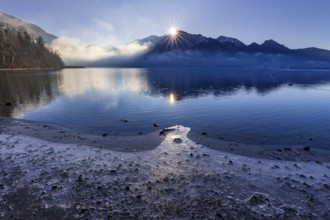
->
[137, 31, 330, 62]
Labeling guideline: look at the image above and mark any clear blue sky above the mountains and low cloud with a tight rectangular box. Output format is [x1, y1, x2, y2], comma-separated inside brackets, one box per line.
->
[0, 0, 330, 49]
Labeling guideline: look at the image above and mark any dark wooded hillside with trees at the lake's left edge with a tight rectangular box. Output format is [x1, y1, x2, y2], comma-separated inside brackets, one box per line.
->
[0, 29, 64, 68]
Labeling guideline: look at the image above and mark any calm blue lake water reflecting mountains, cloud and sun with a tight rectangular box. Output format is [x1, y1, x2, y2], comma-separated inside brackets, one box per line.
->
[0, 68, 330, 149]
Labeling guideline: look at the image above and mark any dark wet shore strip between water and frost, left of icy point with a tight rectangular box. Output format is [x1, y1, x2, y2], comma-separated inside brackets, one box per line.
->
[0, 118, 164, 152]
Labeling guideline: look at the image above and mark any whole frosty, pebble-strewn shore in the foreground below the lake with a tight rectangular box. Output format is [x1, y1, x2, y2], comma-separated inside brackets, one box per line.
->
[0, 119, 330, 219]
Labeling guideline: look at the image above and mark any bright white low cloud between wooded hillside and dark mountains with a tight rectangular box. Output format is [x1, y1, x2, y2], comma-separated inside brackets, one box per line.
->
[50, 36, 152, 66]
